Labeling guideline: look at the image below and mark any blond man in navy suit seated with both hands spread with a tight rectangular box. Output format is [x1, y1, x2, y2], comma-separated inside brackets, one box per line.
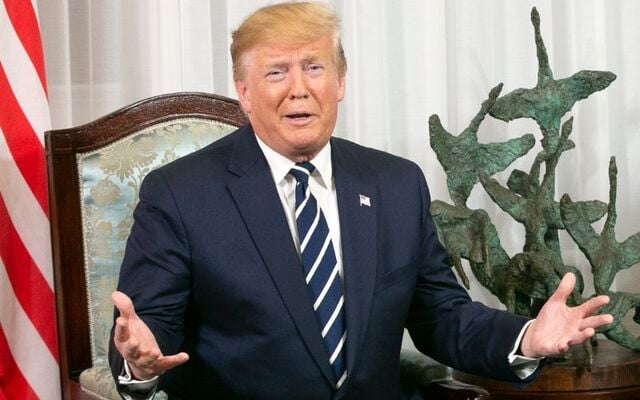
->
[110, 3, 612, 399]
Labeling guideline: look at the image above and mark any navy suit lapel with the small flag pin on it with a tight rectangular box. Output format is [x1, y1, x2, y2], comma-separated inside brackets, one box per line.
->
[331, 139, 378, 380]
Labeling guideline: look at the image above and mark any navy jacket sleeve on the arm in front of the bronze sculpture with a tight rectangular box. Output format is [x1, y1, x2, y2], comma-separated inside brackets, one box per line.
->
[406, 166, 536, 383]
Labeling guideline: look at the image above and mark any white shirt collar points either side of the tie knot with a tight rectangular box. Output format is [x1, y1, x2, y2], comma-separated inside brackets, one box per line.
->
[256, 135, 333, 188]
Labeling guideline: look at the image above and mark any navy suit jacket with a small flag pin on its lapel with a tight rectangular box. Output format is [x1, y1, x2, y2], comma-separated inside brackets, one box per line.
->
[110, 126, 526, 399]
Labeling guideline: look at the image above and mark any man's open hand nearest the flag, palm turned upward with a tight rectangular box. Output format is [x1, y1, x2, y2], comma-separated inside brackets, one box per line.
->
[111, 291, 189, 380]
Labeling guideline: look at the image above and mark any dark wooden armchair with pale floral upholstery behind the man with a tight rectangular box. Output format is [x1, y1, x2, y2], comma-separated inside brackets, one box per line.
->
[46, 93, 485, 400]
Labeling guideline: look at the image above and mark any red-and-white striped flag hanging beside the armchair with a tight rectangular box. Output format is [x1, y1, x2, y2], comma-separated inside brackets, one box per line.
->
[0, 0, 60, 400]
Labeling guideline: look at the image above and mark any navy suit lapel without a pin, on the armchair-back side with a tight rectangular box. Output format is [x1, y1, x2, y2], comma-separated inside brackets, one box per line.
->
[229, 127, 335, 385]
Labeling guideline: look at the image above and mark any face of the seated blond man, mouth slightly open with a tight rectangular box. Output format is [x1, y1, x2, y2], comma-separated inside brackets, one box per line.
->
[235, 36, 344, 162]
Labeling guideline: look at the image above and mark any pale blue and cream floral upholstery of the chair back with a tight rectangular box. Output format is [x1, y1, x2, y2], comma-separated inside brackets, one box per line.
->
[77, 118, 236, 400]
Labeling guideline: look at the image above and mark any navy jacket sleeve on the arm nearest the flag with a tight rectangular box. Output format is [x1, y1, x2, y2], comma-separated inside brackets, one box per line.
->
[109, 172, 191, 382]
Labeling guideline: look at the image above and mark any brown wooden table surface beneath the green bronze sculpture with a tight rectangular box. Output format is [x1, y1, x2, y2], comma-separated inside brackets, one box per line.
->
[454, 340, 640, 400]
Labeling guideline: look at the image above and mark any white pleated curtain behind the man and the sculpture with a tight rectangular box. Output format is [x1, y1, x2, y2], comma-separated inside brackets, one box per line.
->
[38, 0, 640, 328]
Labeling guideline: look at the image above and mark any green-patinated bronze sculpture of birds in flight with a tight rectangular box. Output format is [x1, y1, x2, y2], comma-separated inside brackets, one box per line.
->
[429, 8, 640, 353]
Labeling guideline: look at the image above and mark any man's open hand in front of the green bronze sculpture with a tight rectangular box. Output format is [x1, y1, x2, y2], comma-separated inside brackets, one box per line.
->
[520, 273, 613, 358]
